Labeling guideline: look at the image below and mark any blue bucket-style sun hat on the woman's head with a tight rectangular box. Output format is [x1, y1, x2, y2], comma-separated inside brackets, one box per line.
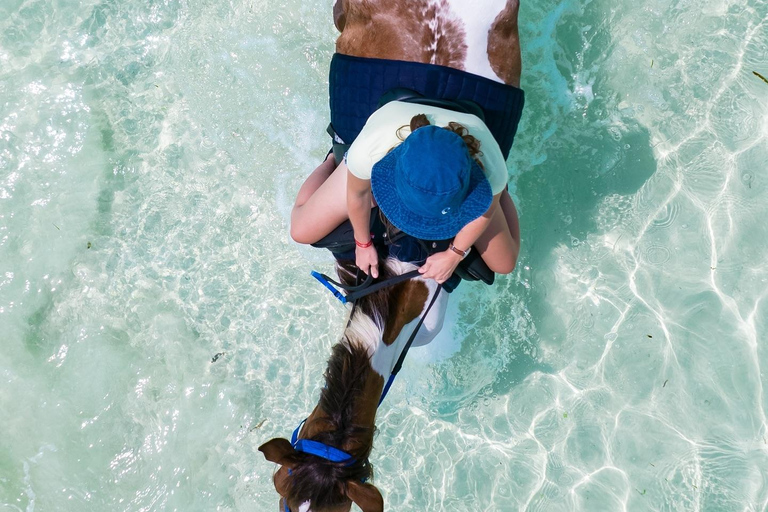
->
[371, 125, 493, 240]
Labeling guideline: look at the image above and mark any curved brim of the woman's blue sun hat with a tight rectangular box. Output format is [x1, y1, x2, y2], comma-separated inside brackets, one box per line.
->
[371, 145, 493, 240]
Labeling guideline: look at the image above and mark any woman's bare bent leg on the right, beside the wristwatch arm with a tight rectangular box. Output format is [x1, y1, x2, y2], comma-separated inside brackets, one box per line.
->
[475, 190, 520, 274]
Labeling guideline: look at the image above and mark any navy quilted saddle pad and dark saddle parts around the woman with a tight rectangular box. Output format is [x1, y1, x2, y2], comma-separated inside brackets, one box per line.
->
[312, 53, 524, 292]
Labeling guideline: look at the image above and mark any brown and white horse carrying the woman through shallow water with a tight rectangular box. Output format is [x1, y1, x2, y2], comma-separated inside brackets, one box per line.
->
[259, 0, 521, 512]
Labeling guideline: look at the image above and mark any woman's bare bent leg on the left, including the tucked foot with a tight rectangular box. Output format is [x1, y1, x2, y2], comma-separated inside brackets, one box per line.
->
[291, 155, 349, 244]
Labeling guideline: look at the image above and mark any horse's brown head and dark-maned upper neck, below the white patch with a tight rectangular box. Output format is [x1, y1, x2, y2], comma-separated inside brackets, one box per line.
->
[259, 340, 384, 512]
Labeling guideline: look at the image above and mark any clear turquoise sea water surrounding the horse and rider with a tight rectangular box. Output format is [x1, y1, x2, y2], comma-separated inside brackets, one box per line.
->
[0, 0, 768, 512]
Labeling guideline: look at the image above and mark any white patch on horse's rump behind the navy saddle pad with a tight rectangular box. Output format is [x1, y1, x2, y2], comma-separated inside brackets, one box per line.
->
[440, 0, 507, 83]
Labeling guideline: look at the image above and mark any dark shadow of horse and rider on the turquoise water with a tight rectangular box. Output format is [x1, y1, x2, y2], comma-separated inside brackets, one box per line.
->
[435, 2, 657, 408]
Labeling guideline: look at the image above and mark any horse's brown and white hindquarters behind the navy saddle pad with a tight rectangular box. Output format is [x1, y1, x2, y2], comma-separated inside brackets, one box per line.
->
[334, 0, 520, 86]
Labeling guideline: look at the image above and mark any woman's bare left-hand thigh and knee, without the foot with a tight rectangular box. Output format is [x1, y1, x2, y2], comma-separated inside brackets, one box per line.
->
[291, 164, 349, 244]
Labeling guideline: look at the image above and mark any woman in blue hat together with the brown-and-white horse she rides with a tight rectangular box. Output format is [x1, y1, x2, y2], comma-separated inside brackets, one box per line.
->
[259, 0, 523, 512]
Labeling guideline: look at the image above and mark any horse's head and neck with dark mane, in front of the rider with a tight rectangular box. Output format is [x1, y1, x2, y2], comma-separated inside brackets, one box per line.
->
[259, 260, 448, 512]
